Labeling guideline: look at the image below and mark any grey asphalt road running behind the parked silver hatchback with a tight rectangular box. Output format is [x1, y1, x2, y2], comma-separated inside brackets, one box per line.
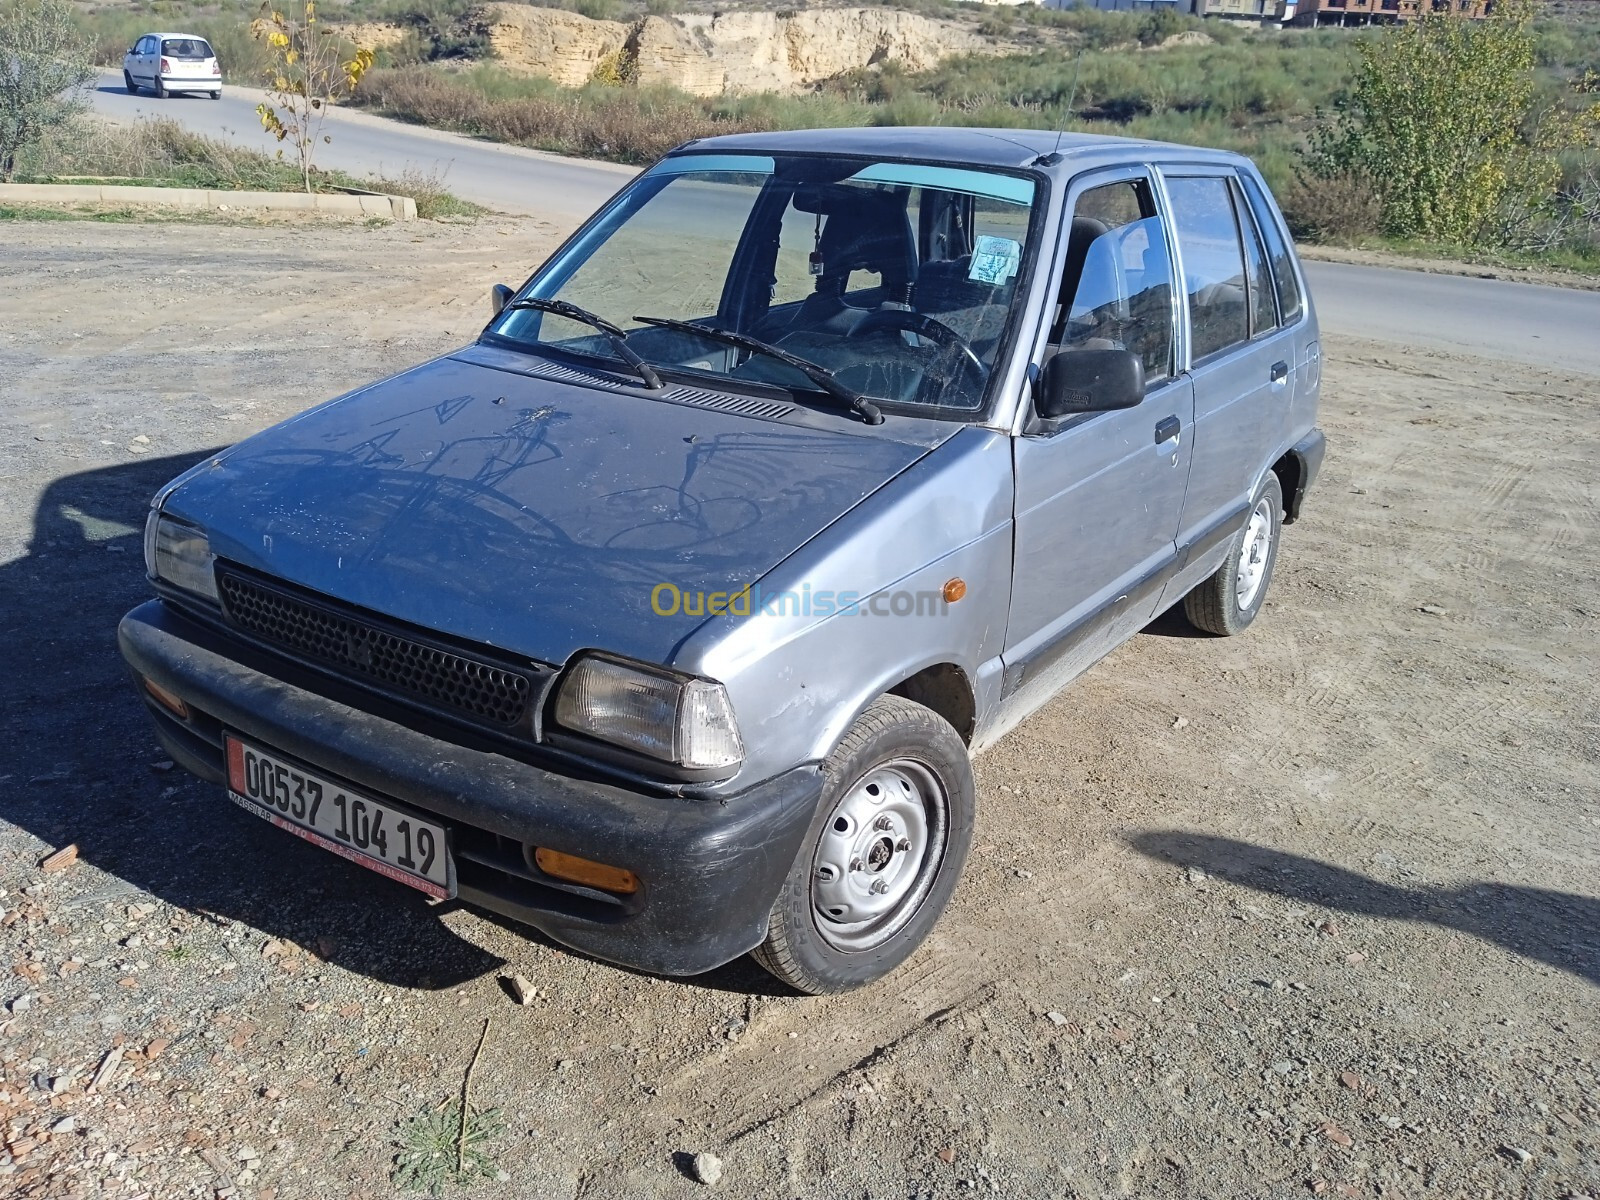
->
[93, 72, 1600, 374]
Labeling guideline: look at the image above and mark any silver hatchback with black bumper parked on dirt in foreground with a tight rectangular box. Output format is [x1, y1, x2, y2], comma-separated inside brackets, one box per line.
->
[120, 128, 1323, 992]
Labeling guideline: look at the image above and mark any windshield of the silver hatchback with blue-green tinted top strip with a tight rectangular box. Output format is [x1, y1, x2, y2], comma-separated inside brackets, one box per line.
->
[490, 154, 1035, 416]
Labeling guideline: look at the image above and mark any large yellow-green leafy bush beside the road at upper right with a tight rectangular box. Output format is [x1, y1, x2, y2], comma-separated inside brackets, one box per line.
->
[1307, 0, 1592, 245]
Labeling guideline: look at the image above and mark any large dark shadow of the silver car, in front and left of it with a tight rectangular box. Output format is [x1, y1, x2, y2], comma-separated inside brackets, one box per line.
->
[0, 451, 787, 994]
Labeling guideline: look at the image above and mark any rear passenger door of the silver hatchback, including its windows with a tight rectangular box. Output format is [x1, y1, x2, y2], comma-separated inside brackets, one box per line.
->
[1165, 168, 1296, 574]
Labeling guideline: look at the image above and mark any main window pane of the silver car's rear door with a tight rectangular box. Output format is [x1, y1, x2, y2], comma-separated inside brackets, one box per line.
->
[1166, 176, 1250, 362]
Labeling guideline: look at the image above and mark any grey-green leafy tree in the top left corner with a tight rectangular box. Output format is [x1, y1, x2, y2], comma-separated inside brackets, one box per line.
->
[0, 0, 94, 179]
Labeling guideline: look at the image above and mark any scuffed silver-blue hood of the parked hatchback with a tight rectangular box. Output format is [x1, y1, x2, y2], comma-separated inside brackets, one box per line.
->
[163, 347, 958, 662]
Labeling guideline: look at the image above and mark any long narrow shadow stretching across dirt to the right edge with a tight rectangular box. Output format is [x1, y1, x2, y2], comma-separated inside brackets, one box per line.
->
[1128, 830, 1600, 984]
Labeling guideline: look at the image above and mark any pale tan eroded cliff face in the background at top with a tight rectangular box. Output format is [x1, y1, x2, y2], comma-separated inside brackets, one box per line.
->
[358, 5, 1000, 96]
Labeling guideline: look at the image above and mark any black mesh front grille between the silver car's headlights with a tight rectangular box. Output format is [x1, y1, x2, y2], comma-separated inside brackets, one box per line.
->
[218, 570, 533, 725]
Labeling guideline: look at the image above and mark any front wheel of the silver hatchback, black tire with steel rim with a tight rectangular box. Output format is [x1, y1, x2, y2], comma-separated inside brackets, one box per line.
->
[752, 696, 974, 995]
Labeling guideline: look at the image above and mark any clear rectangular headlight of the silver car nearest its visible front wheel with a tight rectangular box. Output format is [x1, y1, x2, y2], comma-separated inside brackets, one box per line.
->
[555, 656, 744, 770]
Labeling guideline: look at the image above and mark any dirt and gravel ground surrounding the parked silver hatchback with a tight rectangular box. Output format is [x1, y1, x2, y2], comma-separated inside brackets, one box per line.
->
[0, 221, 1600, 1200]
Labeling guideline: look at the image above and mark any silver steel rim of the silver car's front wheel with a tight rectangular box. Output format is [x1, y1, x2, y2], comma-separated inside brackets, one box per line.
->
[811, 758, 949, 952]
